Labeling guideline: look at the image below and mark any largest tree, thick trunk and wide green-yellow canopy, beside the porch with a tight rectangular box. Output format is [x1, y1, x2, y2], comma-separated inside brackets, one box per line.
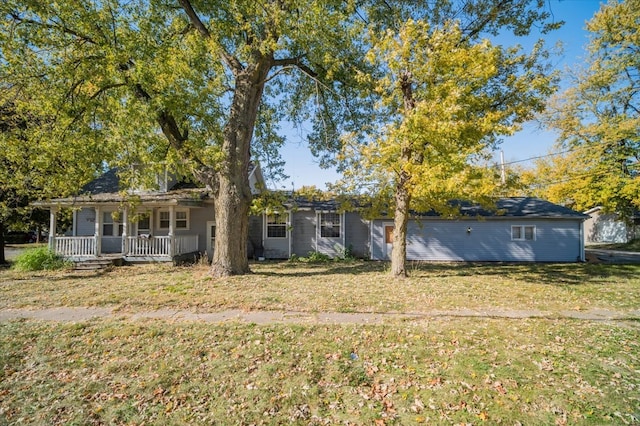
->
[0, 0, 376, 276]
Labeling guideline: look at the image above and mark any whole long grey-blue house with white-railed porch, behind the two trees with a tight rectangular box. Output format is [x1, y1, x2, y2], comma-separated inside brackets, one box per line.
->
[36, 167, 587, 262]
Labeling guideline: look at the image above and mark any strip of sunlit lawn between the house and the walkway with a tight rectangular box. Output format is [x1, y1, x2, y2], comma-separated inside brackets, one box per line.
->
[0, 262, 640, 313]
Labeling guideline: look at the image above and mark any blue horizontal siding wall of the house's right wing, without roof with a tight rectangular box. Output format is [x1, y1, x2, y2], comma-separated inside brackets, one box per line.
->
[372, 219, 582, 262]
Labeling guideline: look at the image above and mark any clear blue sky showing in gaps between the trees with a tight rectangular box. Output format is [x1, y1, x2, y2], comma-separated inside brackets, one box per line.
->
[273, 0, 602, 189]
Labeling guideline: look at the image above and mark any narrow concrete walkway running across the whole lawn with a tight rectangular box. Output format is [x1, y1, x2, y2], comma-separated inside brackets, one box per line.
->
[0, 307, 640, 327]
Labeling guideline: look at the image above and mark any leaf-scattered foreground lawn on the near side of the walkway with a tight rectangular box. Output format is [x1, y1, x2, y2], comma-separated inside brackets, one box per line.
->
[0, 319, 640, 425]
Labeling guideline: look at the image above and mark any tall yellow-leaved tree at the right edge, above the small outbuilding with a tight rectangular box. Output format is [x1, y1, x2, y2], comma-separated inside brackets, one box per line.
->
[532, 0, 640, 217]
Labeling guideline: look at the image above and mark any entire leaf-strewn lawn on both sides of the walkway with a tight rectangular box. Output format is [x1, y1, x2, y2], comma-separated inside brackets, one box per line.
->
[0, 262, 640, 425]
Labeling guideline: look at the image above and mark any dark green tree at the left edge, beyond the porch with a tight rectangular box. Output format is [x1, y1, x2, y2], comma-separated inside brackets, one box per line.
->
[0, 90, 103, 263]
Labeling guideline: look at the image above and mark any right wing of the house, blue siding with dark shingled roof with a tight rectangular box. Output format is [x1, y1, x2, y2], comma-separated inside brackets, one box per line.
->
[371, 197, 587, 262]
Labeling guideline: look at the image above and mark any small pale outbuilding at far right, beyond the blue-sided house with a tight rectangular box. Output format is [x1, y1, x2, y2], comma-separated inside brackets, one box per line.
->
[584, 206, 640, 244]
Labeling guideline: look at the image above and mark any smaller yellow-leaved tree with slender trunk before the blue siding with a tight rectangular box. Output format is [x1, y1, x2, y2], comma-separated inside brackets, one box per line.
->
[343, 1, 554, 276]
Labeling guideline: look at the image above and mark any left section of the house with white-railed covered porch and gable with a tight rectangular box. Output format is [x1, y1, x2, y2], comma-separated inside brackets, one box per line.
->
[34, 165, 264, 262]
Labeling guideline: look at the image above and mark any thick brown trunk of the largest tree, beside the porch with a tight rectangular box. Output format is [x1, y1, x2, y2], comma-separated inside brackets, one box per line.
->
[211, 58, 272, 277]
